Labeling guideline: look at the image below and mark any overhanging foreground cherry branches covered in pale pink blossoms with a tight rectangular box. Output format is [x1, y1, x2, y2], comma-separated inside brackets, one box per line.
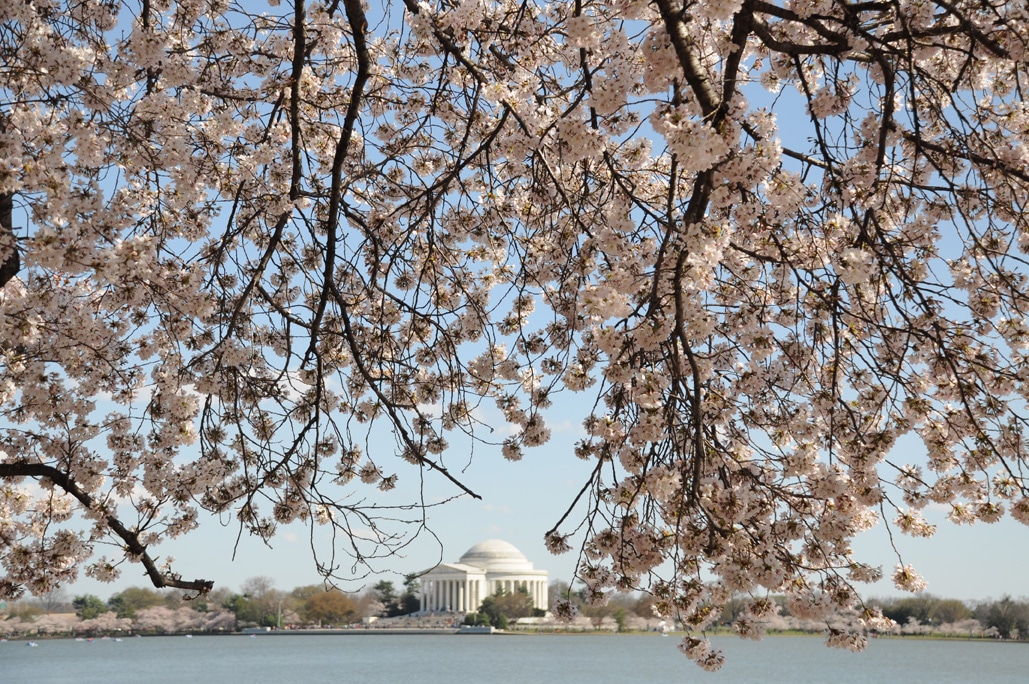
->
[0, 0, 1029, 669]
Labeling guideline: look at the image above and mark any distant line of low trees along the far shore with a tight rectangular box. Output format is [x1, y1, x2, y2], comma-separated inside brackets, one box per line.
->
[0, 576, 1029, 641]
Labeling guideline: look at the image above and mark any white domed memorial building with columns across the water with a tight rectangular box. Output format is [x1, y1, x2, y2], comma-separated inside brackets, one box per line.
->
[421, 539, 547, 613]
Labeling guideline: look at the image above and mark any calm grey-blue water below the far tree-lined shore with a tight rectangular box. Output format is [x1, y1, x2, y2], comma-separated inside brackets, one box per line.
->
[0, 634, 1029, 684]
